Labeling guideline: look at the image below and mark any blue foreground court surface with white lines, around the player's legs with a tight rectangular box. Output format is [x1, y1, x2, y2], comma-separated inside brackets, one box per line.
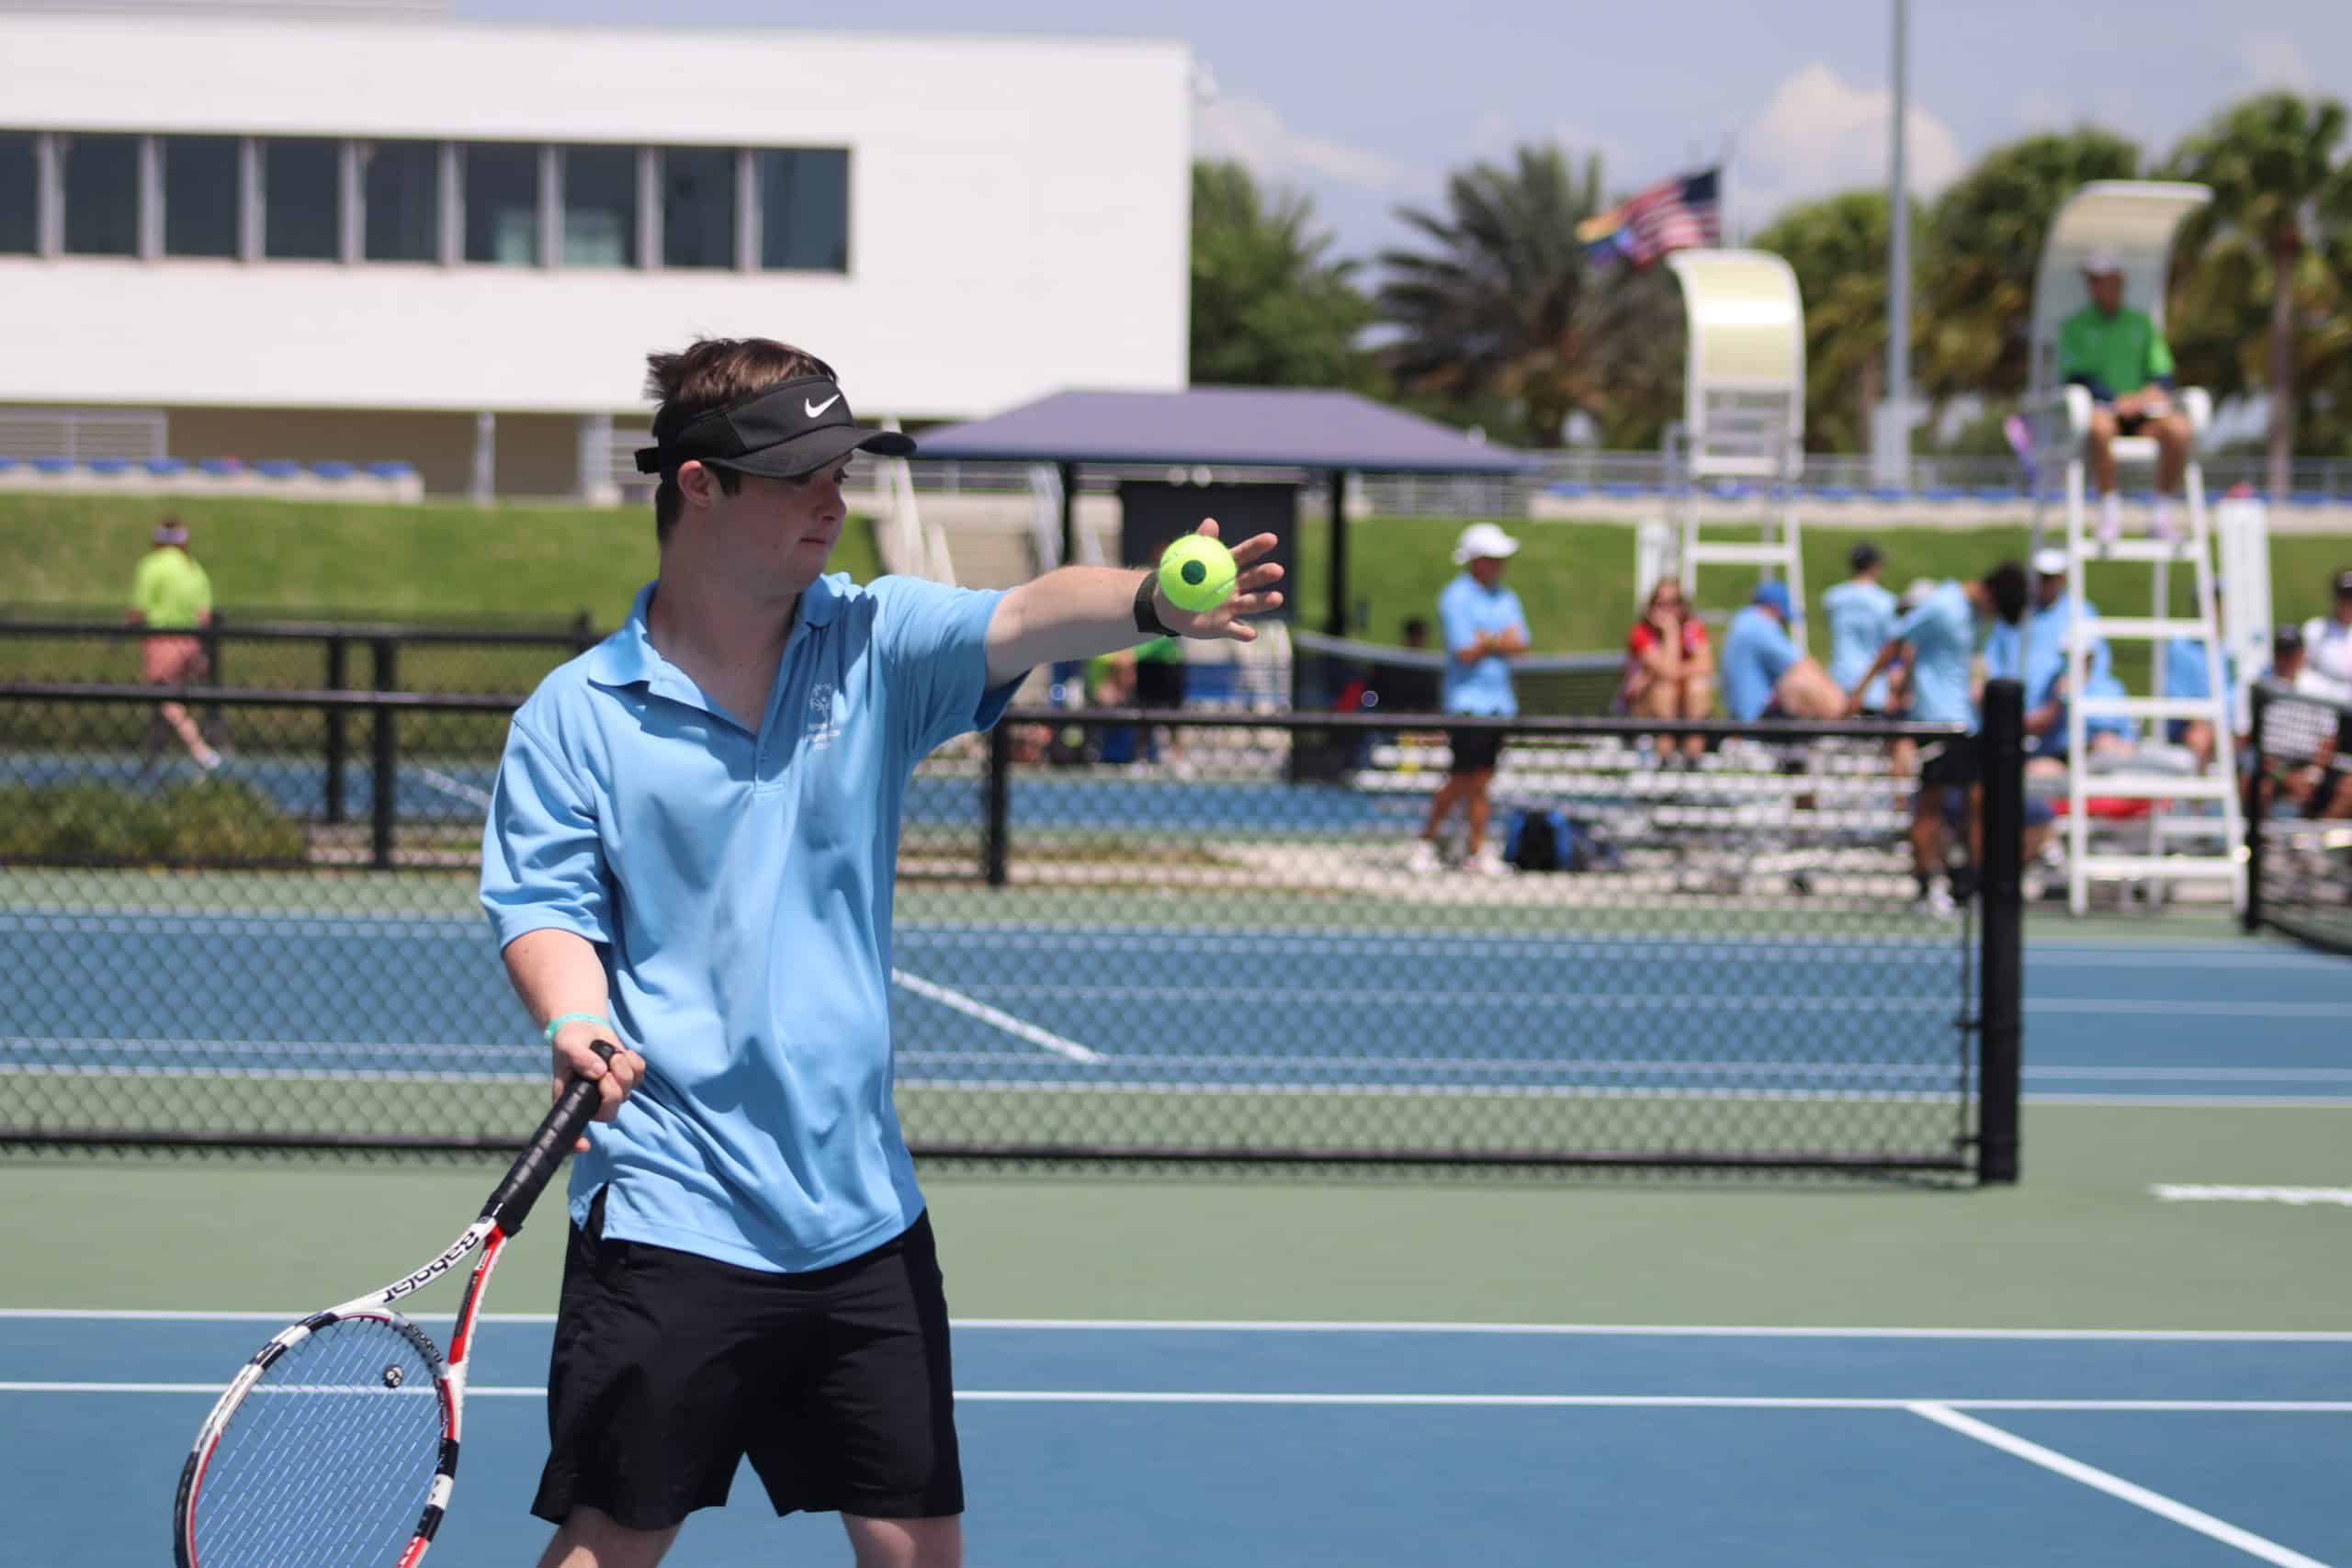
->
[0, 1312, 2352, 1568]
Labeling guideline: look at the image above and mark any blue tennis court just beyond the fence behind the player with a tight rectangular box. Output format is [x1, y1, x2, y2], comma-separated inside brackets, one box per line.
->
[0, 908, 2352, 1102]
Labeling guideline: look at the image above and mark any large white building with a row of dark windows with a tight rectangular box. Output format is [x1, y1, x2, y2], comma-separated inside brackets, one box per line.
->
[0, 0, 1193, 493]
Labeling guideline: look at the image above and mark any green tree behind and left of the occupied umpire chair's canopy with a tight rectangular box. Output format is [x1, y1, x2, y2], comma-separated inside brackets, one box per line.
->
[1917, 125, 2141, 402]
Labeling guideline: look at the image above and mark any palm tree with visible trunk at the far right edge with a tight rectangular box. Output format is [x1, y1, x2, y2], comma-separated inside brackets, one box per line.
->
[2168, 92, 2345, 501]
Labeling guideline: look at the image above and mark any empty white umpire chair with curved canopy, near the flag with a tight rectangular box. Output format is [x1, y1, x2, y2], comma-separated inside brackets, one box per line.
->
[1665, 249, 1804, 647]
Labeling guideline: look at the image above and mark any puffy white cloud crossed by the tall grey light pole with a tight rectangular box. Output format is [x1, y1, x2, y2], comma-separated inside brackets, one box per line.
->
[1731, 62, 1964, 223]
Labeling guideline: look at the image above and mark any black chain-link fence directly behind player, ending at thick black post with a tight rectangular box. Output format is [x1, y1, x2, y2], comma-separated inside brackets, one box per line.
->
[0, 684, 2023, 1180]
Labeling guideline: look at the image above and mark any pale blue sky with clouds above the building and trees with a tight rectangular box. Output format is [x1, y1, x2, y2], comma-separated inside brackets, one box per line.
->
[457, 0, 2352, 256]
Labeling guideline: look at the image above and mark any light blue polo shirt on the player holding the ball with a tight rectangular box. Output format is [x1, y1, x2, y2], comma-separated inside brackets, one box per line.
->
[482, 576, 1013, 1272]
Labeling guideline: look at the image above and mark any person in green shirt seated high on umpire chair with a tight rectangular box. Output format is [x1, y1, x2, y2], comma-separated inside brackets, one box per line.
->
[2058, 247, 2189, 546]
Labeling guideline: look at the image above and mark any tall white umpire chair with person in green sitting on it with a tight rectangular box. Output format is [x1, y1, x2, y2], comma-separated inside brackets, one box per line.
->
[2025, 181, 2246, 915]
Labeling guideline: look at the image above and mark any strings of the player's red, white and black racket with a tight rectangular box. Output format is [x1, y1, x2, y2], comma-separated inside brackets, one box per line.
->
[195, 1319, 442, 1568]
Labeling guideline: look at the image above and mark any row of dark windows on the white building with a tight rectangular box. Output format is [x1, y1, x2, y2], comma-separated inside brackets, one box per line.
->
[0, 131, 849, 273]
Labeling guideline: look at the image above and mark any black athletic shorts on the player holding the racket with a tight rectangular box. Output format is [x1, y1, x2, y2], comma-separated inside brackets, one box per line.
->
[532, 1194, 965, 1530]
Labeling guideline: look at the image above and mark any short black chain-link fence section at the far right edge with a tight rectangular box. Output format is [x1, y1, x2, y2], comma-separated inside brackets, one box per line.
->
[2246, 682, 2352, 954]
